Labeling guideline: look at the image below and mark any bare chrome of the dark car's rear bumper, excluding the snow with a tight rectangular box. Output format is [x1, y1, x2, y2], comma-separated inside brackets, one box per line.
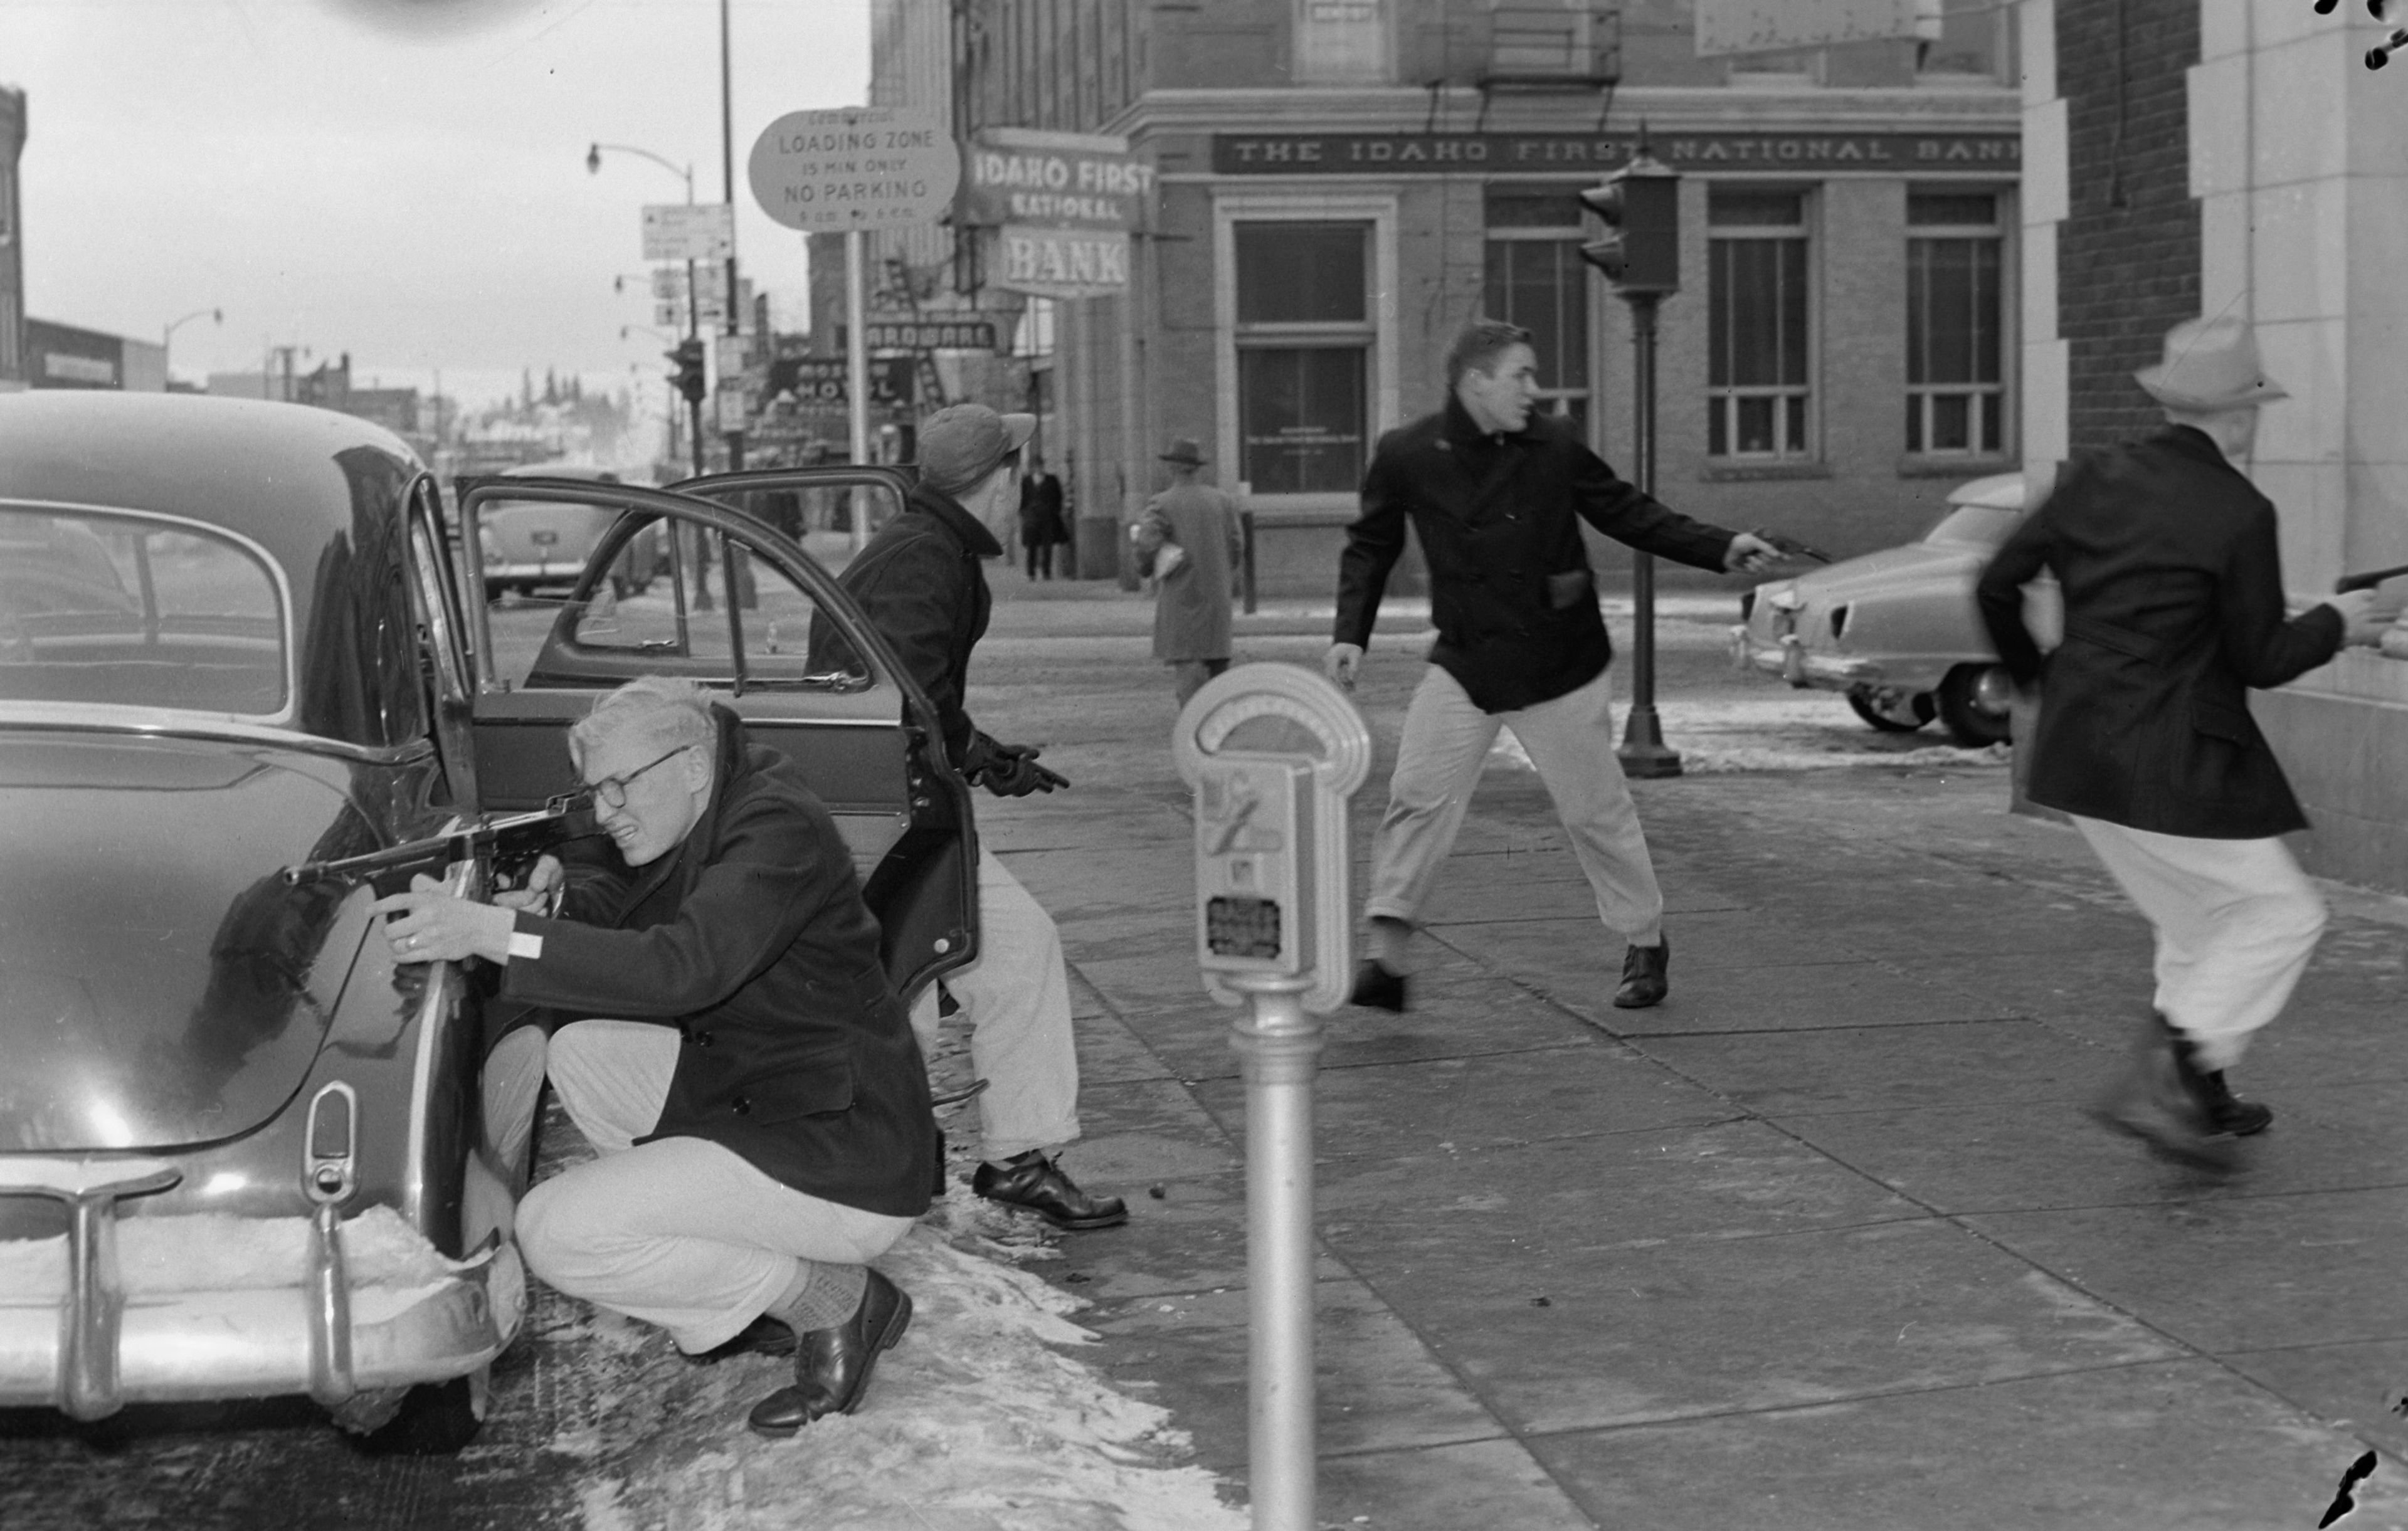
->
[0, 1158, 525, 1420]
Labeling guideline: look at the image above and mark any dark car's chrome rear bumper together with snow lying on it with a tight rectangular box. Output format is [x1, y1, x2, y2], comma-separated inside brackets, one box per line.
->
[0, 1160, 525, 1420]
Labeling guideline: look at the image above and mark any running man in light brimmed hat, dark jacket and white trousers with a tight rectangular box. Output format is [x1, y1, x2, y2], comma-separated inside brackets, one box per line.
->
[1977, 318, 2382, 1165]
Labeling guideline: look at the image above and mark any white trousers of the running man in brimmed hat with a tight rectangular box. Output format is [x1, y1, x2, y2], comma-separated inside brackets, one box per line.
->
[2073, 816, 2324, 1069]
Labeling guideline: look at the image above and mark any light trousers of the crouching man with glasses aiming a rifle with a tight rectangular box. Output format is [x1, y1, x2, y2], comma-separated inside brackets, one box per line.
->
[503, 1021, 917, 1353]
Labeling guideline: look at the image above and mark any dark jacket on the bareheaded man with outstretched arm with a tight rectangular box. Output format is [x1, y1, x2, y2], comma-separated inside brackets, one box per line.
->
[1334, 395, 1731, 713]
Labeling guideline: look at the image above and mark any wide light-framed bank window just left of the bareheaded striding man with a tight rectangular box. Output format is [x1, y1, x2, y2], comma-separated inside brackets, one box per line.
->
[1233, 221, 1373, 493]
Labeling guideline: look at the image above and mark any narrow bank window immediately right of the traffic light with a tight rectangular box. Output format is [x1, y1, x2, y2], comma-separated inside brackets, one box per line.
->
[1705, 190, 1814, 458]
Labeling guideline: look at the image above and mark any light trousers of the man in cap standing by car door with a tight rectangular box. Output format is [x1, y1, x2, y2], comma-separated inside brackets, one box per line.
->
[911, 845, 1079, 1160]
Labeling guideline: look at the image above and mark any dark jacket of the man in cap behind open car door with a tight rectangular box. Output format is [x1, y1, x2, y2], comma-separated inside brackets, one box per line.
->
[811, 484, 1004, 766]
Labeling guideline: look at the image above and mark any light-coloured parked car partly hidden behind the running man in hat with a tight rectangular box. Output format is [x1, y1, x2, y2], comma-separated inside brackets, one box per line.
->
[1731, 474, 2061, 746]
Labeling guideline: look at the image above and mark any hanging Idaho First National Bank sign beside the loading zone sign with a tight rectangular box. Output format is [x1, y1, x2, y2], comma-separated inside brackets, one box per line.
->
[963, 128, 1153, 298]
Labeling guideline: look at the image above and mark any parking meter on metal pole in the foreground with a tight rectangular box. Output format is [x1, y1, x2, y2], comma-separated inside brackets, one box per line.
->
[1170, 665, 1370, 1531]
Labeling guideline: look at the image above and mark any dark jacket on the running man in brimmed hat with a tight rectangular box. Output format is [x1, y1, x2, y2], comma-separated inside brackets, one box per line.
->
[1975, 426, 2343, 840]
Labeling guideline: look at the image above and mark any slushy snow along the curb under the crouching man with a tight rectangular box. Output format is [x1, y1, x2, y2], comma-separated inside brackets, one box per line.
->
[534, 1026, 1247, 1531]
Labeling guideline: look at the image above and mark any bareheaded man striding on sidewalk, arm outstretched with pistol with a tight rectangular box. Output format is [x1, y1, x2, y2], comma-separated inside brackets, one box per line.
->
[1324, 318, 1780, 1011]
